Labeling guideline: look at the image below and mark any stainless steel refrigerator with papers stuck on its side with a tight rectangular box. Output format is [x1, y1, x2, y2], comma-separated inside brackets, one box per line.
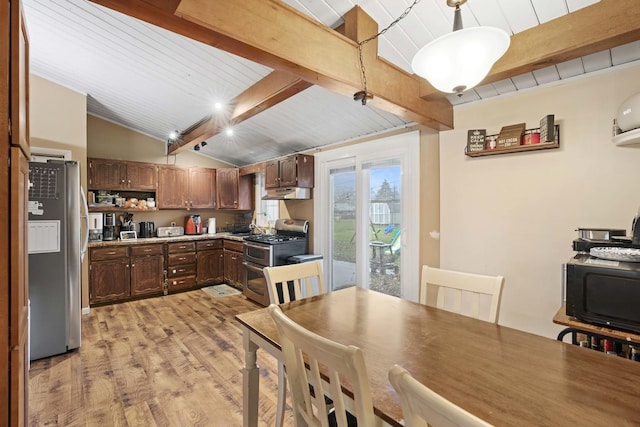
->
[28, 160, 86, 360]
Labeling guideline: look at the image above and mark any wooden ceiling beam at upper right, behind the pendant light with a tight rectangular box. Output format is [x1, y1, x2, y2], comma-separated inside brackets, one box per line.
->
[420, 0, 640, 99]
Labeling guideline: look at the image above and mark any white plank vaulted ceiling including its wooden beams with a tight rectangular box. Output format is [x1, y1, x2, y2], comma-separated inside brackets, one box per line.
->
[23, 0, 640, 166]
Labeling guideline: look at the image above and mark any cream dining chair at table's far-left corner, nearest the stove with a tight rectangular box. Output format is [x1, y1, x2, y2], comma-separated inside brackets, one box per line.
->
[263, 260, 327, 427]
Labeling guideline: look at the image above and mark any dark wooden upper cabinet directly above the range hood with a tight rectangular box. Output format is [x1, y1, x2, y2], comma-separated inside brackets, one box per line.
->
[265, 154, 314, 188]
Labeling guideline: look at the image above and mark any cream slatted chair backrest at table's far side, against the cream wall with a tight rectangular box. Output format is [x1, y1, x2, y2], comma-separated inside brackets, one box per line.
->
[420, 265, 504, 323]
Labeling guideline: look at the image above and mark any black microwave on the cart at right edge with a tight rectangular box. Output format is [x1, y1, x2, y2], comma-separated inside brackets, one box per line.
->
[566, 254, 640, 333]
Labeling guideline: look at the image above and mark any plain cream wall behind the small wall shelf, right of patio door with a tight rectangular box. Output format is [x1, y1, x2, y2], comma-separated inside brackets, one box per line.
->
[440, 64, 640, 337]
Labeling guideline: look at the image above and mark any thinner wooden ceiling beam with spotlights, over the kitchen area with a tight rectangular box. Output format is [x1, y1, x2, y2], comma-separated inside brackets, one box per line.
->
[168, 71, 312, 154]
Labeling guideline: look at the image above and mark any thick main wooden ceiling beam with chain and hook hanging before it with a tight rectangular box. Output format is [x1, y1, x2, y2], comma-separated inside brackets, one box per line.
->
[91, 0, 453, 130]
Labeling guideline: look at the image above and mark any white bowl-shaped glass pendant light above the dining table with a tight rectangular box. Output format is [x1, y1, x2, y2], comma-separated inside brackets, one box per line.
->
[411, 0, 511, 96]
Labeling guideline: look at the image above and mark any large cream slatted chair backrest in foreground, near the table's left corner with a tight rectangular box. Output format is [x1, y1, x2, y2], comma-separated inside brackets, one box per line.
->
[268, 304, 375, 427]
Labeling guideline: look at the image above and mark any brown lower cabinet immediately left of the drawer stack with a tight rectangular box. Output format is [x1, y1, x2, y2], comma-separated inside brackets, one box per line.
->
[130, 244, 164, 296]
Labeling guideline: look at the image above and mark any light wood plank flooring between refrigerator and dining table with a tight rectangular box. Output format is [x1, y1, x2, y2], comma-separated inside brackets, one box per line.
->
[29, 290, 293, 427]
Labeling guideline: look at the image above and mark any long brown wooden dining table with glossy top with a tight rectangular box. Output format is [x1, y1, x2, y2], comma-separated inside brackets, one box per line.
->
[237, 287, 640, 426]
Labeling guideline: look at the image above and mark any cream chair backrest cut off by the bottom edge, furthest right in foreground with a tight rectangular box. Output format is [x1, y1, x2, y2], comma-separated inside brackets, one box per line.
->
[389, 365, 491, 427]
